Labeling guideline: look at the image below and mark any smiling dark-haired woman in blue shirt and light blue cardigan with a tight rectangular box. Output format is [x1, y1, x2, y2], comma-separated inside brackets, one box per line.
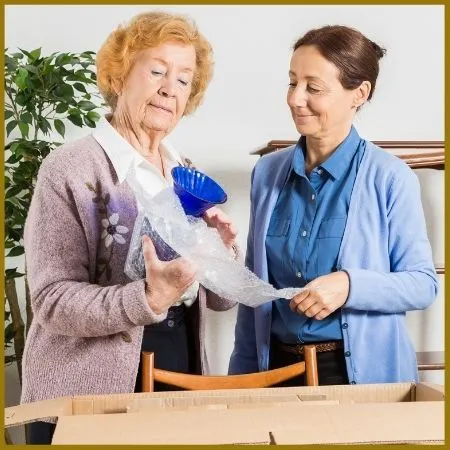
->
[229, 26, 437, 384]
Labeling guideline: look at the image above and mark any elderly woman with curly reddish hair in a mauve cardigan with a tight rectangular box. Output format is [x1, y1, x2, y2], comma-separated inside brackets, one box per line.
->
[21, 12, 236, 444]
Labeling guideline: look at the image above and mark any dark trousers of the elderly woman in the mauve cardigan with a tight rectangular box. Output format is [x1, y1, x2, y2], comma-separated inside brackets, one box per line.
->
[26, 302, 200, 445]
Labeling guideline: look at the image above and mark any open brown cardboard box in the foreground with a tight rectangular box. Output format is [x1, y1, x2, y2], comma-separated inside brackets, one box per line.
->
[5, 383, 444, 445]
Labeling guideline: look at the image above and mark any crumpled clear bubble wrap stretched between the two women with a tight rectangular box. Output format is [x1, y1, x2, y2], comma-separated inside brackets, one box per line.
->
[125, 188, 302, 307]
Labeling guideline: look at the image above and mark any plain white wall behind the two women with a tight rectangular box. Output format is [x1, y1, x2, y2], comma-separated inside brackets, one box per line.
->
[5, 5, 444, 424]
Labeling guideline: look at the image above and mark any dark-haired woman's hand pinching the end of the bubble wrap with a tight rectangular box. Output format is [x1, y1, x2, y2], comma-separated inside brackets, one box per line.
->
[289, 271, 350, 320]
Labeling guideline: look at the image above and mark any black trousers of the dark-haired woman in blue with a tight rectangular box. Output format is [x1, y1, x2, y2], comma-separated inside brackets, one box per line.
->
[269, 336, 349, 387]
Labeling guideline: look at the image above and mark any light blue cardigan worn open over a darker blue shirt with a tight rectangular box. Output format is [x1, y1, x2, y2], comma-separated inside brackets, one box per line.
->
[229, 141, 437, 383]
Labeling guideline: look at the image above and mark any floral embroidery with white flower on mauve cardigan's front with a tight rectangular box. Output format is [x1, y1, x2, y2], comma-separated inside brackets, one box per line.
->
[85, 181, 129, 281]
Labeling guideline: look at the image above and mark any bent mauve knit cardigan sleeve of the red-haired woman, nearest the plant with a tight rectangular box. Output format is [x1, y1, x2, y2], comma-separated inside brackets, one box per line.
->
[24, 154, 166, 337]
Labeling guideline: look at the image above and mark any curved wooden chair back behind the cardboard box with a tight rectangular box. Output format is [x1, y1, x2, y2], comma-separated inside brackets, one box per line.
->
[142, 345, 319, 392]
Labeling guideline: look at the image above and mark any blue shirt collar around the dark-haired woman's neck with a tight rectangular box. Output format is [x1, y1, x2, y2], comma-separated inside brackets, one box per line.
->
[292, 126, 361, 180]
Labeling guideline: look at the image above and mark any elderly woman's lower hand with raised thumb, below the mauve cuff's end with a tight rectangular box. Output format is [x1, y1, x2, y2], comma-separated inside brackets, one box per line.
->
[142, 236, 196, 314]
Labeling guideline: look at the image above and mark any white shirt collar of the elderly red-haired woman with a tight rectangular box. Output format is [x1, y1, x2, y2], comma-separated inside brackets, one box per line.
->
[92, 115, 182, 183]
